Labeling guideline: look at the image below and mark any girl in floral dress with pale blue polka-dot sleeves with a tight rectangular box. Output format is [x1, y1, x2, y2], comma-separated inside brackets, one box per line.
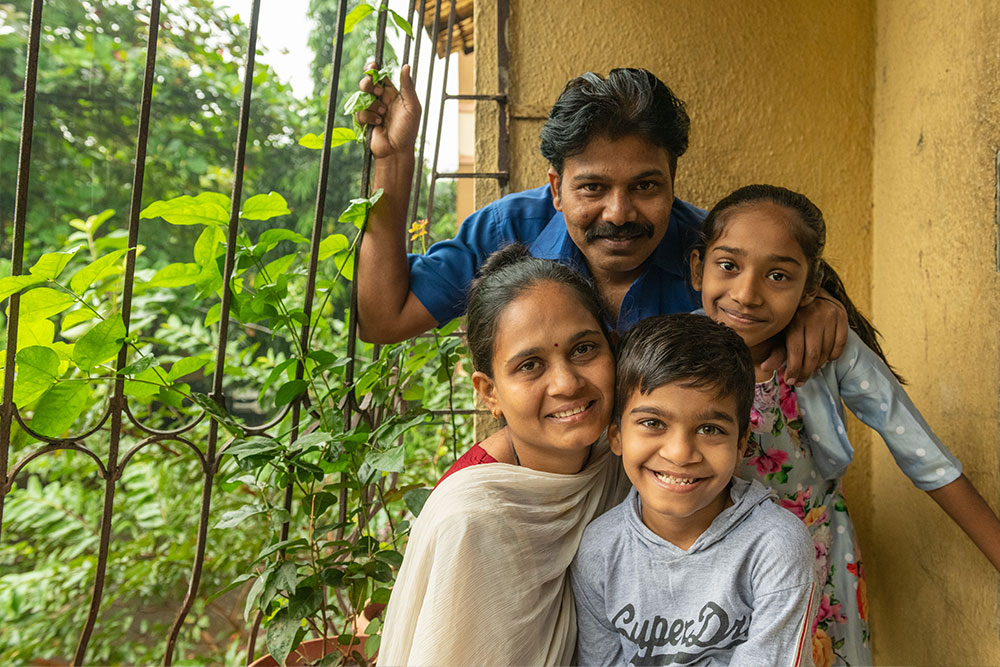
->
[691, 185, 1000, 667]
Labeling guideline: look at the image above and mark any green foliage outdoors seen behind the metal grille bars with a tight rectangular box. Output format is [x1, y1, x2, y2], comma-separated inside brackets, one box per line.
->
[0, 0, 471, 664]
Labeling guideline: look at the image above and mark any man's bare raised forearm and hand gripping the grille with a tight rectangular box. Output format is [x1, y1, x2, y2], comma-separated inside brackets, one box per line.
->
[355, 63, 437, 343]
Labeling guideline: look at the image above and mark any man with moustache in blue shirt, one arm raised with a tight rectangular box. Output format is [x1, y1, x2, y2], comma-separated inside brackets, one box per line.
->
[357, 66, 847, 382]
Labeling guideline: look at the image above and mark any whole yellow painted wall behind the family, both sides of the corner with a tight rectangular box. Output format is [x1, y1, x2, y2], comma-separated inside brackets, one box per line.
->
[475, 0, 1000, 665]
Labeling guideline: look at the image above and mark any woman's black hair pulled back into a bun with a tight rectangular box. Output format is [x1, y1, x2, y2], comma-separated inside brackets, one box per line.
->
[466, 243, 609, 377]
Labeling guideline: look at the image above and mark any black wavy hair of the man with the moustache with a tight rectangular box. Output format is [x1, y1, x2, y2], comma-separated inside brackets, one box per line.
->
[541, 67, 691, 174]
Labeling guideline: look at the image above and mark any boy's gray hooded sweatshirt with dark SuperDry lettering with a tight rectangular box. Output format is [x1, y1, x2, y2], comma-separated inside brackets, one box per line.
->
[570, 478, 818, 667]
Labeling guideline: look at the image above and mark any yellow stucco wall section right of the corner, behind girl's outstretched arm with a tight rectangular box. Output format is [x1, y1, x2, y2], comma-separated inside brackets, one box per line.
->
[871, 0, 1000, 665]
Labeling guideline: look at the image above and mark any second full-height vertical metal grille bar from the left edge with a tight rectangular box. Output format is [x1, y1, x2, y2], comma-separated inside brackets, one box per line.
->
[73, 0, 160, 665]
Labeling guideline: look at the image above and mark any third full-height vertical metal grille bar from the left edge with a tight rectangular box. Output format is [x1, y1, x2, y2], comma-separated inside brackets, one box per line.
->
[163, 0, 260, 666]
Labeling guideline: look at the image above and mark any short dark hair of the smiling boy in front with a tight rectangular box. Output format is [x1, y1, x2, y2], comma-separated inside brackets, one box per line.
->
[612, 313, 755, 438]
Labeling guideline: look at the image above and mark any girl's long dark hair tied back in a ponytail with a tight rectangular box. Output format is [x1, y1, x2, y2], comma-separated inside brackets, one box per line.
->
[694, 185, 904, 384]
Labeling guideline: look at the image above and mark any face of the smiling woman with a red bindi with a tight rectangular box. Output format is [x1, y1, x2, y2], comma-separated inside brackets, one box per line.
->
[472, 282, 615, 472]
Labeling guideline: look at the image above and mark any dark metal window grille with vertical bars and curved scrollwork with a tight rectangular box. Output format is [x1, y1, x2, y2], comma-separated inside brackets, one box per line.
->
[0, 0, 509, 665]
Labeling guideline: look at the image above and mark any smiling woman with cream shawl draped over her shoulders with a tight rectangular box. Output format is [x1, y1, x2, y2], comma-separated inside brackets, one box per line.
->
[379, 245, 627, 665]
